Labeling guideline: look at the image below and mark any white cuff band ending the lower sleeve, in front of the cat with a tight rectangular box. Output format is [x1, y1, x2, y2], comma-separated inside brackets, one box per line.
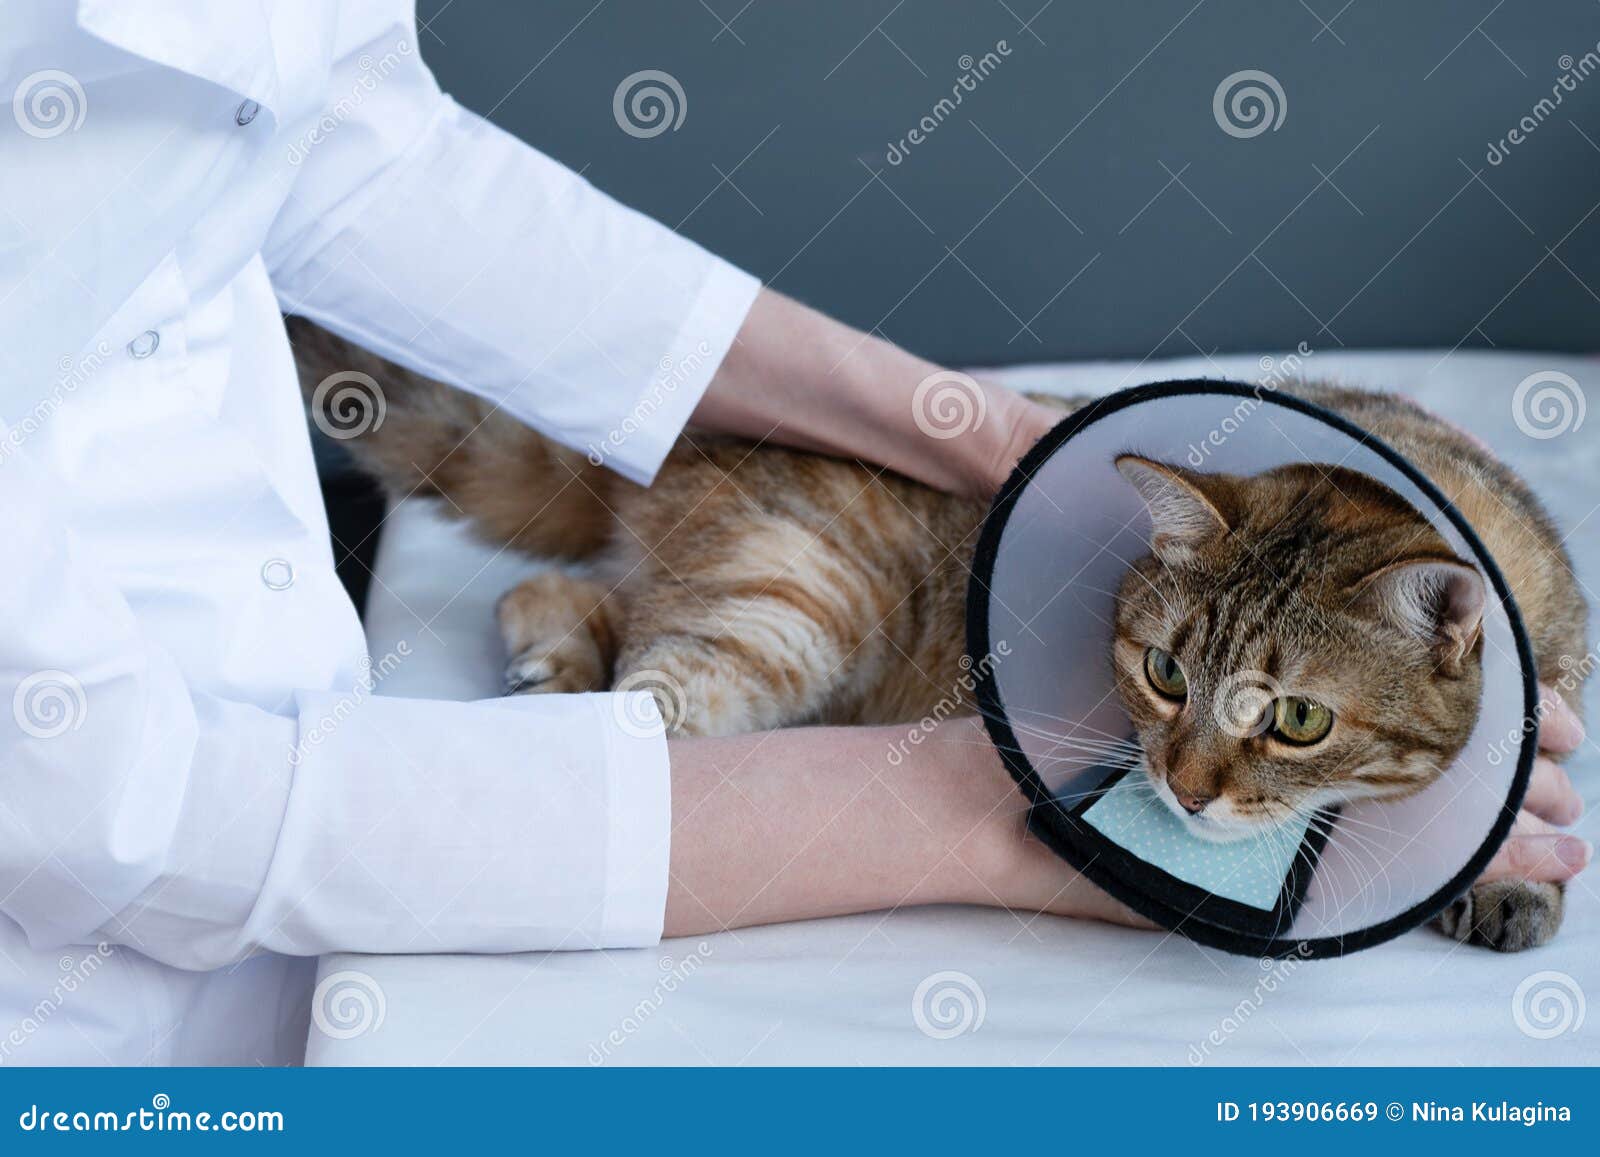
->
[601, 691, 672, 947]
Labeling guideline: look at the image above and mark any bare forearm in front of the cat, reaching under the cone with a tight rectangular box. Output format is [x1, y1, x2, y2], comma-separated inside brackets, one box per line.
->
[666, 719, 1149, 936]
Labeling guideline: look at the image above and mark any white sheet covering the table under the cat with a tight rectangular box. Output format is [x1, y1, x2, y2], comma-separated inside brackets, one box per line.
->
[307, 352, 1600, 1066]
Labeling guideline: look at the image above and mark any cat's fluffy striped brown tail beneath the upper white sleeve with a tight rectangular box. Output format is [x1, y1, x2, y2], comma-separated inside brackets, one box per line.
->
[288, 318, 629, 558]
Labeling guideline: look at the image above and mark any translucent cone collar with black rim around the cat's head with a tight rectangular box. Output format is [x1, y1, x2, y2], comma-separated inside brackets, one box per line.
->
[966, 381, 1539, 957]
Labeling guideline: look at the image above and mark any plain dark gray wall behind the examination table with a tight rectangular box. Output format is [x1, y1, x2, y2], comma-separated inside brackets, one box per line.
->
[419, 0, 1600, 363]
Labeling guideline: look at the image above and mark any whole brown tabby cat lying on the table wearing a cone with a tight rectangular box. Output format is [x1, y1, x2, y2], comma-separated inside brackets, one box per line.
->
[291, 320, 1587, 951]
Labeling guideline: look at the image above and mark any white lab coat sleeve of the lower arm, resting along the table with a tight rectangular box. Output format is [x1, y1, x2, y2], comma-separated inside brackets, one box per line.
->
[0, 426, 670, 968]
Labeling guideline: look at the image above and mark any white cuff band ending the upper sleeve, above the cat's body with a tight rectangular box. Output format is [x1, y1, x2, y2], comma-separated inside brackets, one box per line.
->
[589, 258, 762, 486]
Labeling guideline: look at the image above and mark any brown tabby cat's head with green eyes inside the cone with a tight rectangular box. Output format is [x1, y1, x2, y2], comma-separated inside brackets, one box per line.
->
[1112, 454, 1485, 840]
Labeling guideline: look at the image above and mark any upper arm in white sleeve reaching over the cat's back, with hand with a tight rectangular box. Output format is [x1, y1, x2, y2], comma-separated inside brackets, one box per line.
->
[264, 5, 1059, 496]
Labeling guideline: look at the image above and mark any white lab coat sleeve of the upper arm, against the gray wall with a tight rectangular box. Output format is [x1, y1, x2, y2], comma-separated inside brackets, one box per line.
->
[264, 3, 760, 483]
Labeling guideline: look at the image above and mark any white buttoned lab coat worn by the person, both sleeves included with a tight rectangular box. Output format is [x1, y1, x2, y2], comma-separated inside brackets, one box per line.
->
[0, 0, 757, 1064]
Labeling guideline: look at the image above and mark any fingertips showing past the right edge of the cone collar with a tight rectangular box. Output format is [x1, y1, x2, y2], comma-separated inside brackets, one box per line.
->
[1482, 683, 1594, 883]
